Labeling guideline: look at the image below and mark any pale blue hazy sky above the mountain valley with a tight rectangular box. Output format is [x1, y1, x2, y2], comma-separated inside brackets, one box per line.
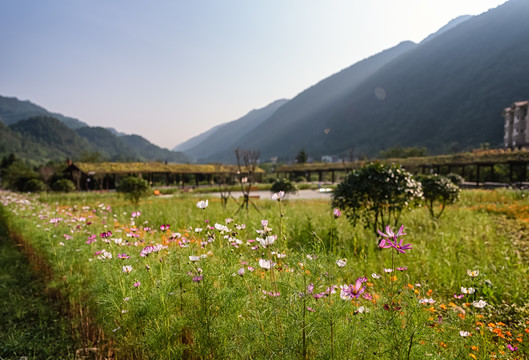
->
[0, 0, 505, 149]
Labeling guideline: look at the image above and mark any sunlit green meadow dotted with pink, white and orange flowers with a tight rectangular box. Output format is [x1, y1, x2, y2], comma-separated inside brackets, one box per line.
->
[0, 190, 529, 359]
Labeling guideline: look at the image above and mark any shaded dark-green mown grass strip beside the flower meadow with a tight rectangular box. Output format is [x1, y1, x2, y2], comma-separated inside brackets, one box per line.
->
[0, 210, 75, 359]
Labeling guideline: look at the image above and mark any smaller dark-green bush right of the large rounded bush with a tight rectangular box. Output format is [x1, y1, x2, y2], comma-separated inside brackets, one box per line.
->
[417, 174, 460, 219]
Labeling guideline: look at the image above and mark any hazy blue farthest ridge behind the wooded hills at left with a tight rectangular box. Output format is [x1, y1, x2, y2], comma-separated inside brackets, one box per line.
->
[0, 96, 88, 129]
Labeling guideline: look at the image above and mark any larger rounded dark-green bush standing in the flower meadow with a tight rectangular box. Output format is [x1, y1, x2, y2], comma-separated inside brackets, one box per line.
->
[332, 162, 422, 233]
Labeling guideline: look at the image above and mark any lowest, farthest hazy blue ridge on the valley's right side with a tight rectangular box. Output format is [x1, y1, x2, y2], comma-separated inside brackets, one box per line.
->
[175, 99, 288, 162]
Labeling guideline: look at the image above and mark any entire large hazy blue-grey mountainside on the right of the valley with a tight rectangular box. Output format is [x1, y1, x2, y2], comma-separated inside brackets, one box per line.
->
[177, 0, 529, 162]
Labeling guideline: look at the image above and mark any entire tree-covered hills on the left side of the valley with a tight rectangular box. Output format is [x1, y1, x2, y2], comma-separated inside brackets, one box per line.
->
[0, 96, 192, 164]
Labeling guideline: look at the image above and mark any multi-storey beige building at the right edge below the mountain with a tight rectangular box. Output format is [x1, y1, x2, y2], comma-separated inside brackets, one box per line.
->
[502, 101, 529, 149]
